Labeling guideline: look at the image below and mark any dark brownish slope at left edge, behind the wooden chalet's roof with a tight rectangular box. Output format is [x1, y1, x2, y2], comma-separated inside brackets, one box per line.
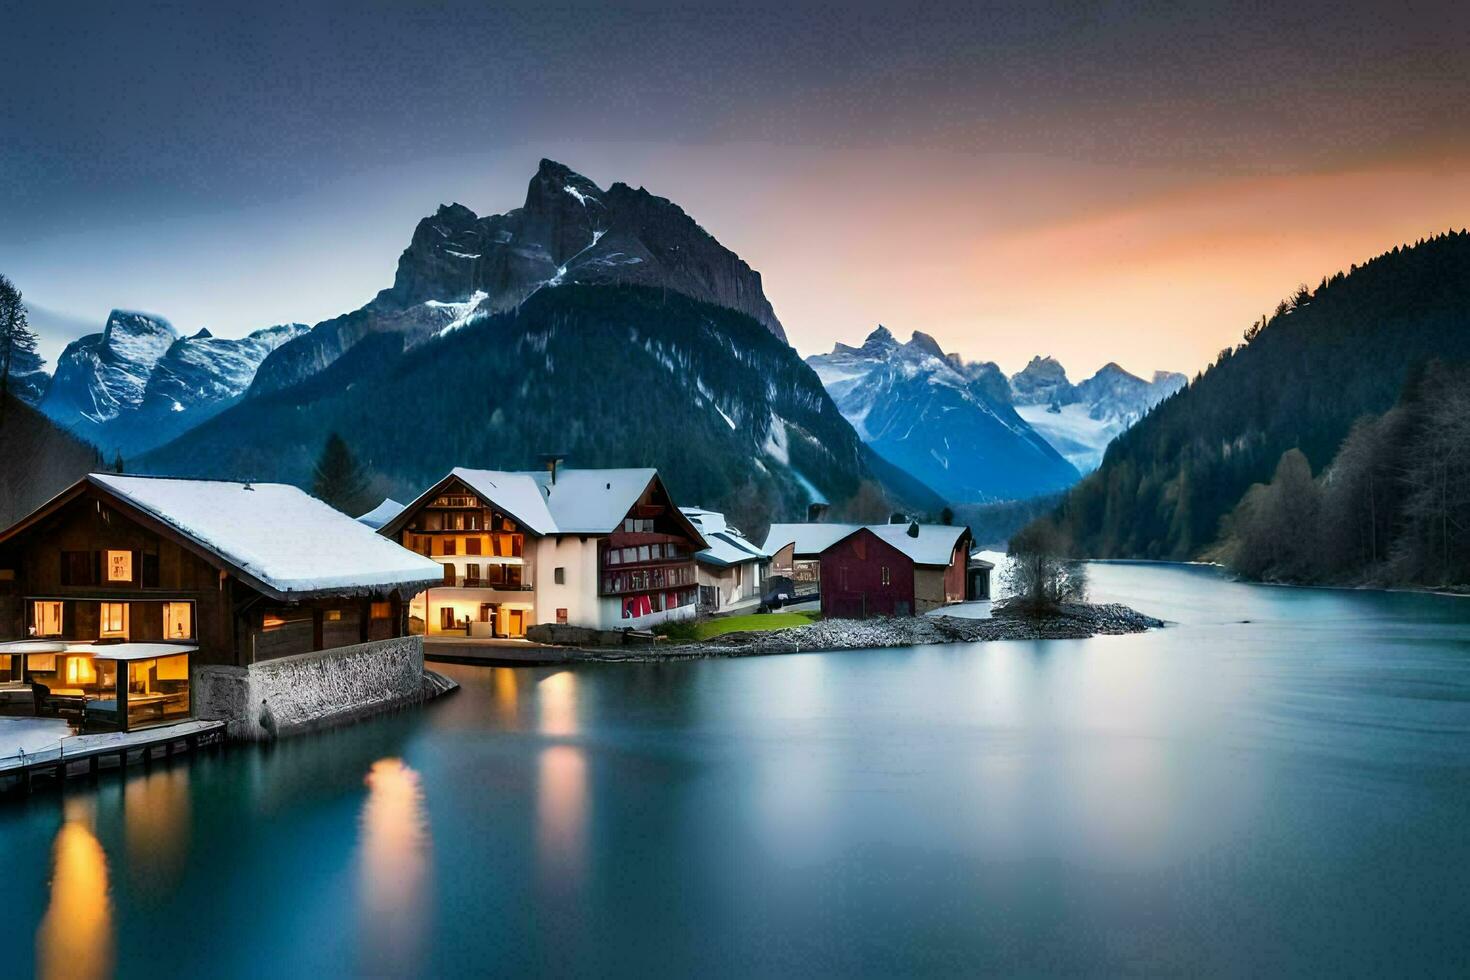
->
[0, 395, 101, 527]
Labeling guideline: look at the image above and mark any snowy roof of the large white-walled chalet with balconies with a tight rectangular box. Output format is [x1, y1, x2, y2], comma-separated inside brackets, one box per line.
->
[399, 466, 679, 535]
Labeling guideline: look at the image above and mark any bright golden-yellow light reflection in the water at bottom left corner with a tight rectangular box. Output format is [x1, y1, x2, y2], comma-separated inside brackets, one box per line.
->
[35, 799, 113, 980]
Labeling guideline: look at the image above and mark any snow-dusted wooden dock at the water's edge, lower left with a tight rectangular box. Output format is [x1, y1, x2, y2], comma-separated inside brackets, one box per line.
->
[0, 721, 225, 793]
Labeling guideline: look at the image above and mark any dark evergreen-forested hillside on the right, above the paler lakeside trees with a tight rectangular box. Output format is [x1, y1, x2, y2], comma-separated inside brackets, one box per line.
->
[1058, 231, 1470, 558]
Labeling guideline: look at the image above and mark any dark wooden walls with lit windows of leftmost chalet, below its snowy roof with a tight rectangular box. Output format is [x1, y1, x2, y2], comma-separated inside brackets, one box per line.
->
[0, 479, 420, 727]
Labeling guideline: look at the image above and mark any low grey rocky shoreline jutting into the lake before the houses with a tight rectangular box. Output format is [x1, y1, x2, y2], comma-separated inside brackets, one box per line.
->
[578, 604, 1164, 663]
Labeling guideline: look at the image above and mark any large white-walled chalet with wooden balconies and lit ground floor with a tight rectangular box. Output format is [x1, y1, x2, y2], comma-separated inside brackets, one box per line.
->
[378, 461, 709, 638]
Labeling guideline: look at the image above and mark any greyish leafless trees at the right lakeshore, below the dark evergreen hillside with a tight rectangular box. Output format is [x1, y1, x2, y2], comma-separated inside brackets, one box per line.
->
[1219, 363, 1470, 586]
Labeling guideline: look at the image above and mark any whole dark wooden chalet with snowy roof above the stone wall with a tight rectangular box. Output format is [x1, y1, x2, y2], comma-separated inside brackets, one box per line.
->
[0, 473, 440, 730]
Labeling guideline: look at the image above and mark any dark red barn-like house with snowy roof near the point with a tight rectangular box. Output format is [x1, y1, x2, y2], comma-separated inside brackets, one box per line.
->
[820, 523, 973, 619]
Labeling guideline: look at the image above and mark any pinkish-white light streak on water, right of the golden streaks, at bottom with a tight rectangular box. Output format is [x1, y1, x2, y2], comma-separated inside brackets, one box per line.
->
[359, 758, 429, 976]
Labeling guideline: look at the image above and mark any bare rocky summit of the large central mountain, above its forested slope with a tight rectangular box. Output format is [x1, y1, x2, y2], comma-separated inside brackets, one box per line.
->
[251, 160, 786, 394]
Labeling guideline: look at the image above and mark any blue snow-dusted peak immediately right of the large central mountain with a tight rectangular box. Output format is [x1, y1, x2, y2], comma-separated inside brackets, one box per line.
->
[807, 326, 1078, 502]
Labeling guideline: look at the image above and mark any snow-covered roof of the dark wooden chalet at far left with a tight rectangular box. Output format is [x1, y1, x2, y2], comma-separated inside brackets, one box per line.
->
[87, 473, 444, 598]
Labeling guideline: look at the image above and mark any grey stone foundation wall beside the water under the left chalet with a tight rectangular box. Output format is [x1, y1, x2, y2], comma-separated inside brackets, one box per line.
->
[193, 636, 441, 741]
